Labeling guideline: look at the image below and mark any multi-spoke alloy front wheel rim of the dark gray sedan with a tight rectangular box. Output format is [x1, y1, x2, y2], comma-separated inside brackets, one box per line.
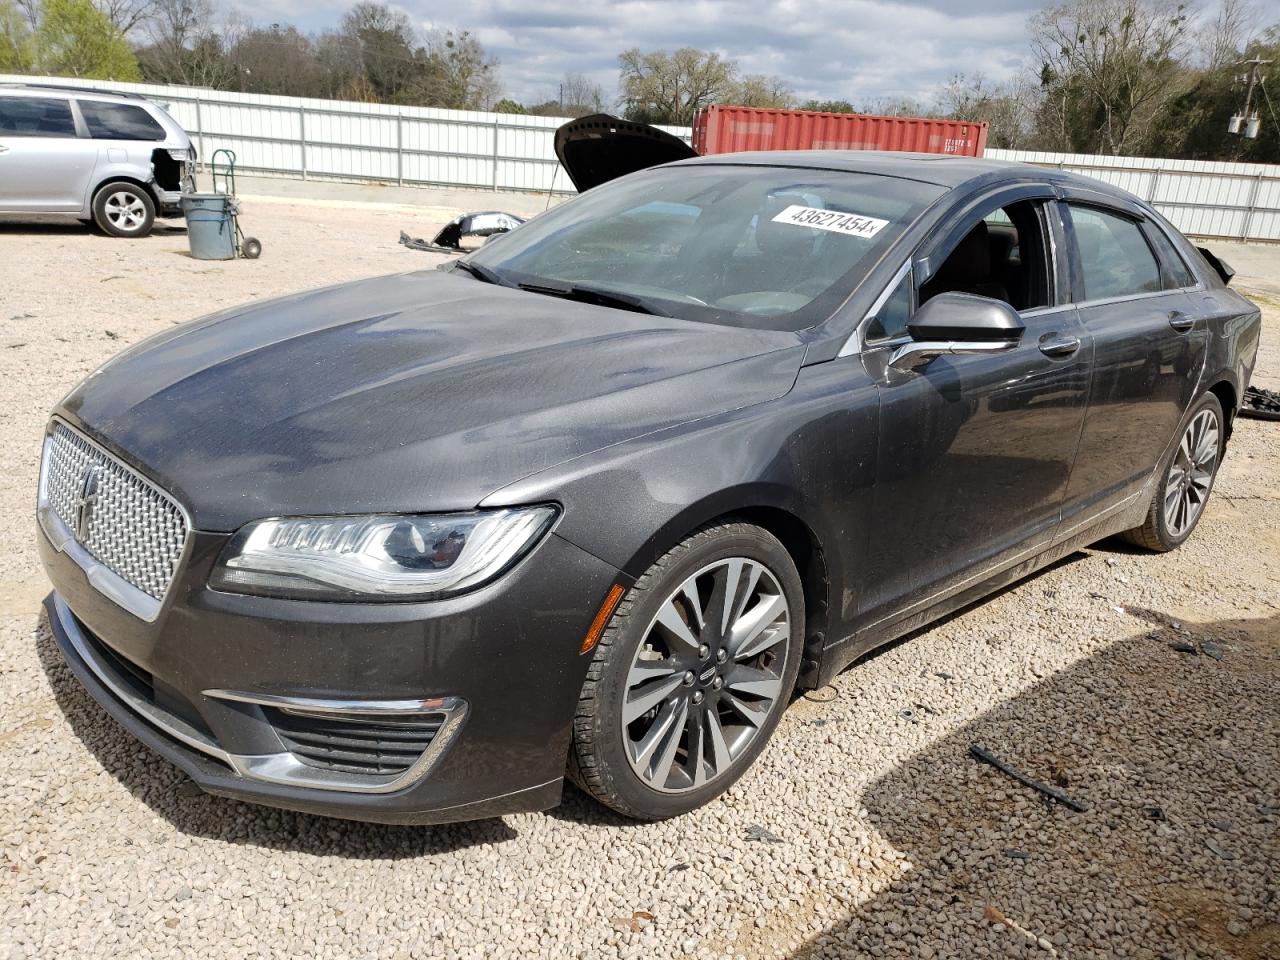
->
[622, 557, 791, 792]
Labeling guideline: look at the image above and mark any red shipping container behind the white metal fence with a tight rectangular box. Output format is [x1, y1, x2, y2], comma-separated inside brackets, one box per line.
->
[694, 105, 987, 156]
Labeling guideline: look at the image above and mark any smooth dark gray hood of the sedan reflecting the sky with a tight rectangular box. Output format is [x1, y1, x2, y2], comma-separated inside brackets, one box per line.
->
[59, 270, 804, 531]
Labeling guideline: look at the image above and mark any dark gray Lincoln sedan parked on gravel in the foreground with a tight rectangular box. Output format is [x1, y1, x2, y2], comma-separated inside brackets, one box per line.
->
[38, 145, 1260, 823]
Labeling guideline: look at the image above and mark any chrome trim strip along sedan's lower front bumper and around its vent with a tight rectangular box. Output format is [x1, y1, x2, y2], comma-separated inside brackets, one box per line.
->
[54, 593, 468, 794]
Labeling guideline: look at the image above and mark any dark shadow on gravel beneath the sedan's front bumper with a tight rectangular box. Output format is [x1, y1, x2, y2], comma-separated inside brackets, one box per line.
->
[36, 607, 516, 860]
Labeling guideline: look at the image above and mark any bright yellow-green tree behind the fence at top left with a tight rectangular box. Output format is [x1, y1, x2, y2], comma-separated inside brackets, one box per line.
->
[35, 0, 142, 81]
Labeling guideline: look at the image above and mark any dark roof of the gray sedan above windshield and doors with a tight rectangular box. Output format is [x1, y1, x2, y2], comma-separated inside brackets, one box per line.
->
[668, 150, 1129, 198]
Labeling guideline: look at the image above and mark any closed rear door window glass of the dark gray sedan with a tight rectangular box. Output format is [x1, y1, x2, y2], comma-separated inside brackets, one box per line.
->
[1068, 204, 1164, 300]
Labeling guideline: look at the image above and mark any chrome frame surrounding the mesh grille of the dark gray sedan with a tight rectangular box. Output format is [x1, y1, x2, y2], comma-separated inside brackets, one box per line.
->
[36, 417, 195, 623]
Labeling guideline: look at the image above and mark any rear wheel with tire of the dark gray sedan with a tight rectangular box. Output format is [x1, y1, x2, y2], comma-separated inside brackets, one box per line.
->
[1121, 393, 1226, 553]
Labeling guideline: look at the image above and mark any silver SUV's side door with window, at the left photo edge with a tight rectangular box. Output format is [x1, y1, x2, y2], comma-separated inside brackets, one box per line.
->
[0, 95, 96, 214]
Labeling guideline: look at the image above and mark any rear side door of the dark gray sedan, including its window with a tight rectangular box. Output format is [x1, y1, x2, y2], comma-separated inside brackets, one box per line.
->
[1062, 192, 1208, 524]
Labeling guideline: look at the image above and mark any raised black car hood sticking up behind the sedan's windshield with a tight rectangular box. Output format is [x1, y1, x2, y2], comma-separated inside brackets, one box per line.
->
[556, 114, 698, 193]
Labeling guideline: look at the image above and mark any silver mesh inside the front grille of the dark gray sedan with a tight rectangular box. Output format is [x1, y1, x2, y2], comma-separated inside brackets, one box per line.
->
[41, 424, 187, 600]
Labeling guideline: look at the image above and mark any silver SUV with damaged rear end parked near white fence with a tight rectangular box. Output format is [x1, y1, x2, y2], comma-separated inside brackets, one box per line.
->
[0, 83, 196, 237]
